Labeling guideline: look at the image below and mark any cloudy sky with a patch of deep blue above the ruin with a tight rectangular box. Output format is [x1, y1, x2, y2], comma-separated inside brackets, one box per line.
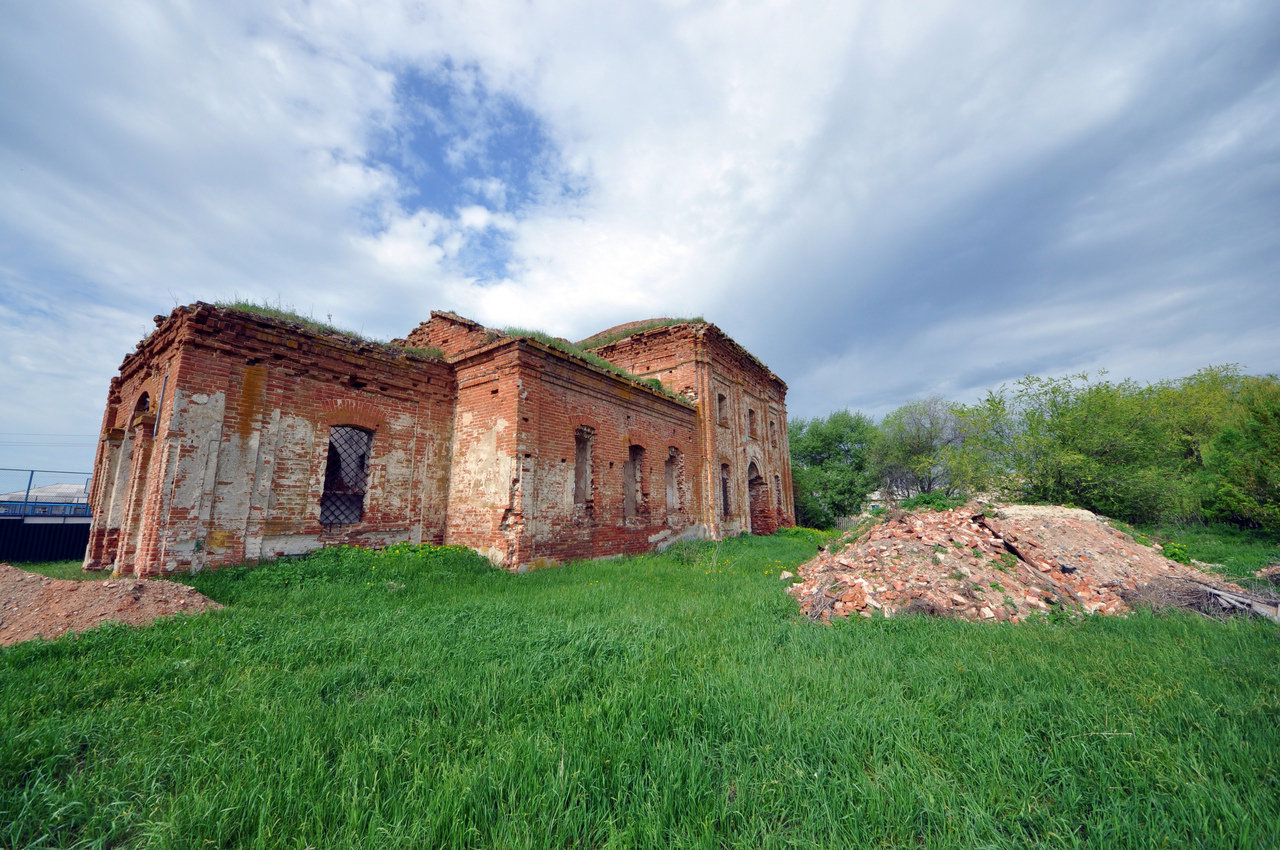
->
[0, 0, 1280, 471]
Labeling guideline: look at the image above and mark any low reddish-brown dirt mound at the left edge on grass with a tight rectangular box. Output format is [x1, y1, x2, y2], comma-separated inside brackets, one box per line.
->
[0, 563, 221, 646]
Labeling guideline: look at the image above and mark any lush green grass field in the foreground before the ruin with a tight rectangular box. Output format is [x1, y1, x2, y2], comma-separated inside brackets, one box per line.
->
[0, 531, 1280, 847]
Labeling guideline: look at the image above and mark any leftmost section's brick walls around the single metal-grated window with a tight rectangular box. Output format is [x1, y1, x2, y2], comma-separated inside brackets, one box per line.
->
[86, 305, 454, 575]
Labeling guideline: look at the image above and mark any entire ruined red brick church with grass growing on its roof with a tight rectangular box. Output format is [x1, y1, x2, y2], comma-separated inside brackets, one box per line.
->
[84, 303, 795, 576]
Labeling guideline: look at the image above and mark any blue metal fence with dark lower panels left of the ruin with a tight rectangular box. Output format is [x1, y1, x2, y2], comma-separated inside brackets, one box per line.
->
[0, 469, 91, 562]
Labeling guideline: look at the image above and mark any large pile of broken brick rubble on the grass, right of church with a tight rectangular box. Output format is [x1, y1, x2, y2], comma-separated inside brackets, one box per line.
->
[790, 503, 1280, 622]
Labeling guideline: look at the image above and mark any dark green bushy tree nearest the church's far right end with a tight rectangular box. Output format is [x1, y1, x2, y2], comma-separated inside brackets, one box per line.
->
[788, 410, 876, 527]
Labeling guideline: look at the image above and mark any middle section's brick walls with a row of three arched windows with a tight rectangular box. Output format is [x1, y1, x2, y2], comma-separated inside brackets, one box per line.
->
[447, 339, 707, 568]
